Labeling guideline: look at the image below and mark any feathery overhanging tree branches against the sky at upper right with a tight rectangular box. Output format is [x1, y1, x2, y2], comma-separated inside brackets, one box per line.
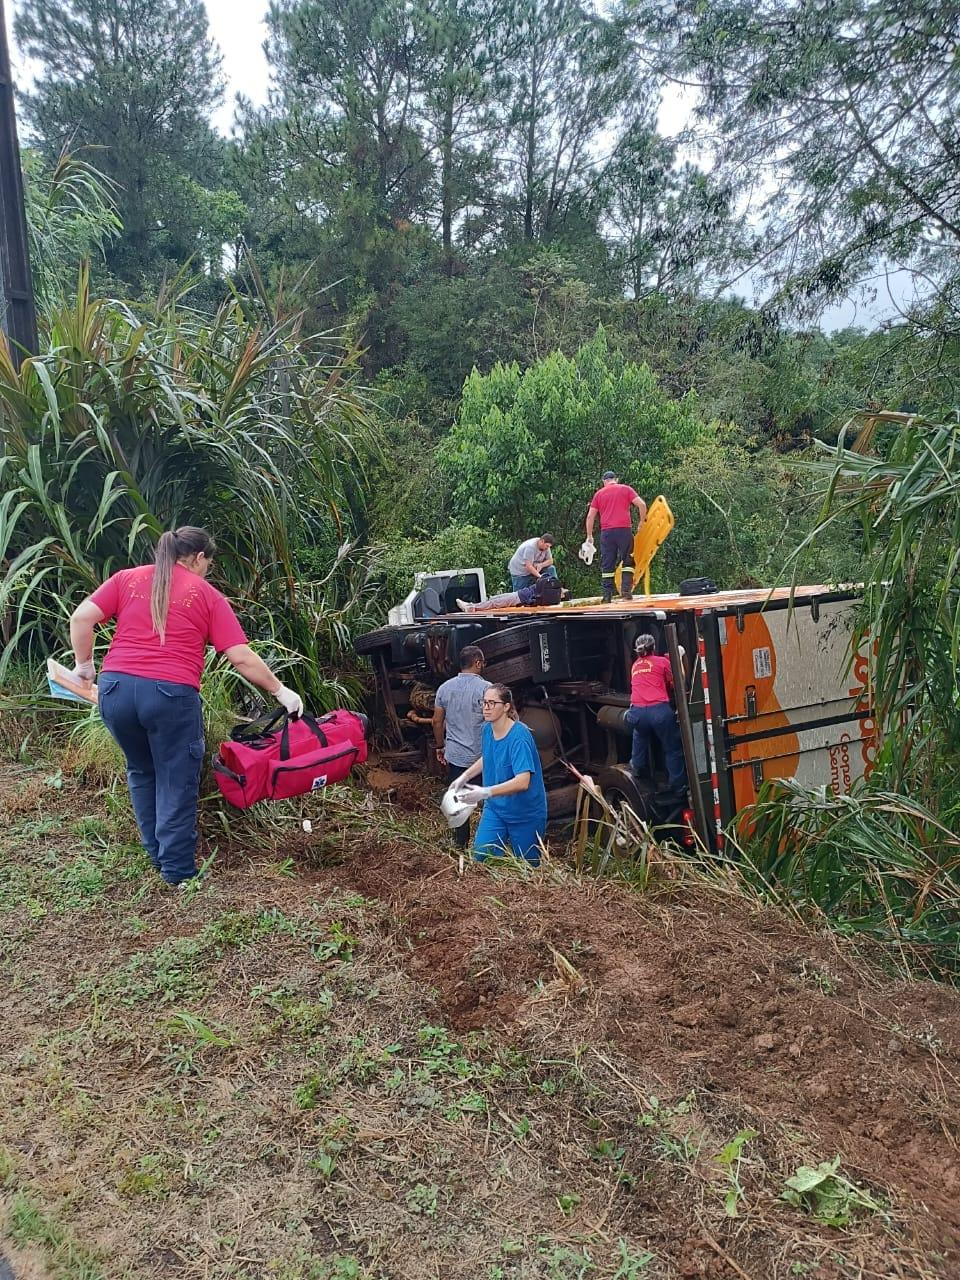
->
[636, 0, 960, 325]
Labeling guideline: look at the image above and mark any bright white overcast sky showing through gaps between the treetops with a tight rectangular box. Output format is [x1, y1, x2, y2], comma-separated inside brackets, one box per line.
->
[6, 0, 910, 332]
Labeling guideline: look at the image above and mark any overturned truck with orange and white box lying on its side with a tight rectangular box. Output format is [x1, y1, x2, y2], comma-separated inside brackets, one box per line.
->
[356, 571, 876, 849]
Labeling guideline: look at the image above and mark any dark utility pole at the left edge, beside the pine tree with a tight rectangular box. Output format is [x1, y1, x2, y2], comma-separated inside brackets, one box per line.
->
[0, 0, 37, 366]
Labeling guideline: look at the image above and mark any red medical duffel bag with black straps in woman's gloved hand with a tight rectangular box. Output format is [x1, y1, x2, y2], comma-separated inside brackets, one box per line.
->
[214, 710, 367, 809]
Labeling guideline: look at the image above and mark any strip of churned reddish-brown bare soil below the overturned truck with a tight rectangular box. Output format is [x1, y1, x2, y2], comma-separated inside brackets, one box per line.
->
[330, 849, 960, 1275]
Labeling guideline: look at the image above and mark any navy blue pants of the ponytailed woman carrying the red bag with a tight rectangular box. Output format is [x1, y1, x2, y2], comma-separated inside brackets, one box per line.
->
[99, 671, 204, 884]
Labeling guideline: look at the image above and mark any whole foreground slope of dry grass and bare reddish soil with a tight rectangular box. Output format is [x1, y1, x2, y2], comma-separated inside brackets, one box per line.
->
[0, 767, 960, 1280]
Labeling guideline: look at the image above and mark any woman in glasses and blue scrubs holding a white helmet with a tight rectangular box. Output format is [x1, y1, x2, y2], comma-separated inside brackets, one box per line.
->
[457, 685, 547, 867]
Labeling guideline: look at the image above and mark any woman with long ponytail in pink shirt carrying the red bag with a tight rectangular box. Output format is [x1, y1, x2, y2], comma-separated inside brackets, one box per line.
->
[70, 525, 303, 884]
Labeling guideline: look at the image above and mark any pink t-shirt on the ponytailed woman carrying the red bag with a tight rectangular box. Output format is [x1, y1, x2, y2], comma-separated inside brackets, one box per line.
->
[91, 564, 247, 689]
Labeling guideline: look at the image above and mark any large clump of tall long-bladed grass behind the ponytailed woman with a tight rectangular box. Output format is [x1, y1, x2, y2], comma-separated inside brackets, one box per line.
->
[0, 270, 371, 704]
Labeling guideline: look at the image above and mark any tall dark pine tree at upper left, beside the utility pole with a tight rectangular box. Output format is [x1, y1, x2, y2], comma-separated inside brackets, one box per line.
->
[15, 0, 229, 284]
